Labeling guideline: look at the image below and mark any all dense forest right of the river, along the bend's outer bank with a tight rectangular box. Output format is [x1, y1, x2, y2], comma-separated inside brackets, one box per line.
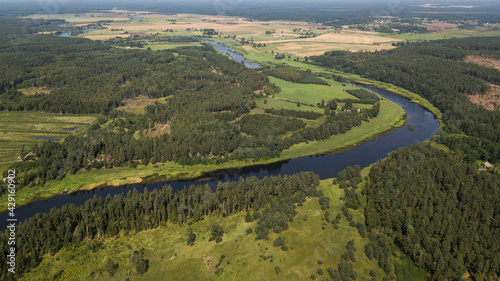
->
[311, 37, 500, 280]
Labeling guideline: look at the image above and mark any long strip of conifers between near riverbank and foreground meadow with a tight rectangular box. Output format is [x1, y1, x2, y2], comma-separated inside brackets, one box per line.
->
[0, 172, 319, 280]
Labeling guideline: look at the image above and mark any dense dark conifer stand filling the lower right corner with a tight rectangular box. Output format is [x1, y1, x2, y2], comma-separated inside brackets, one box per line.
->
[364, 144, 500, 280]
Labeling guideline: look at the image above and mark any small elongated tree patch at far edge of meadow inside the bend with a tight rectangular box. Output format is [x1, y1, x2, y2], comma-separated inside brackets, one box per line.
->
[262, 65, 328, 85]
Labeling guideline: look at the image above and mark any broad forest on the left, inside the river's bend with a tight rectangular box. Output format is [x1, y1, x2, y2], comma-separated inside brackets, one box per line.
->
[0, 17, 379, 194]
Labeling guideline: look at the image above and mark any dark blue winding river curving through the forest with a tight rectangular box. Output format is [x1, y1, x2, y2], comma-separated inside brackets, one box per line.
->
[0, 45, 439, 229]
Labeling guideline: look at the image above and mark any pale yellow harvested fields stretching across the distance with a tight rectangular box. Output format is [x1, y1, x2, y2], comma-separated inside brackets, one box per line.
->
[27, 10, 402, 53]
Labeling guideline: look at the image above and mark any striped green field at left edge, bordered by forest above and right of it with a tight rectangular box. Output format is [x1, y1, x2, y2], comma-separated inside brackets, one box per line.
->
[0, 111, 96, 169]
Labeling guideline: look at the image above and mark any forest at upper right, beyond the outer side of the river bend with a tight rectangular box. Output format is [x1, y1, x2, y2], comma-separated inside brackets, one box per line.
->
[311, 37, 500, 154]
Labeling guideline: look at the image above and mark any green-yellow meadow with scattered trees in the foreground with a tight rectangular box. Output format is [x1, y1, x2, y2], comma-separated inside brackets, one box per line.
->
[23, 169, 423, 280]
